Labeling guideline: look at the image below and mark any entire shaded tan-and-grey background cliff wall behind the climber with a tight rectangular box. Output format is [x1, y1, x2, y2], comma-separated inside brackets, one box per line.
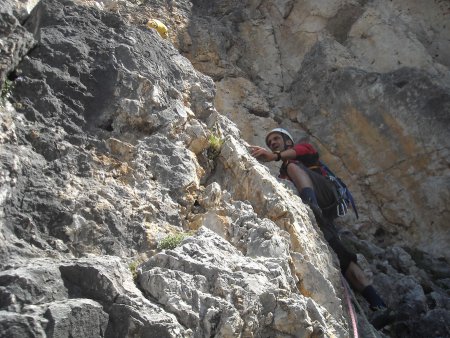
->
[179, 0, 450, 259]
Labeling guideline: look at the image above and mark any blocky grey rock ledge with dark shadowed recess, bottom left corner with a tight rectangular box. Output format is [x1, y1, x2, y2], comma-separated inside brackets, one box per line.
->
[0, 256, 189, 337]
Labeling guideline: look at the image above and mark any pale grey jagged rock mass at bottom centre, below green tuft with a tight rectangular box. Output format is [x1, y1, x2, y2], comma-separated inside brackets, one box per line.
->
[139, 229, 344, 337]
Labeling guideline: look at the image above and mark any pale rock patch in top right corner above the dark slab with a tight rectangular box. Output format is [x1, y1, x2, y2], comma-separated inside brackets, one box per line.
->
[348, 0, 450, 74]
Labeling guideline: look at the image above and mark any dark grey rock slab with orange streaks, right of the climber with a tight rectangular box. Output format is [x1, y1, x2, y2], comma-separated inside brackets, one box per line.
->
[292, 41, 450, 257]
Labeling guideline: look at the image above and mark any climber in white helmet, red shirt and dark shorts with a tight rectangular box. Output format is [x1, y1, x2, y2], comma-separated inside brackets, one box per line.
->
[250, 128, 388, 326]
